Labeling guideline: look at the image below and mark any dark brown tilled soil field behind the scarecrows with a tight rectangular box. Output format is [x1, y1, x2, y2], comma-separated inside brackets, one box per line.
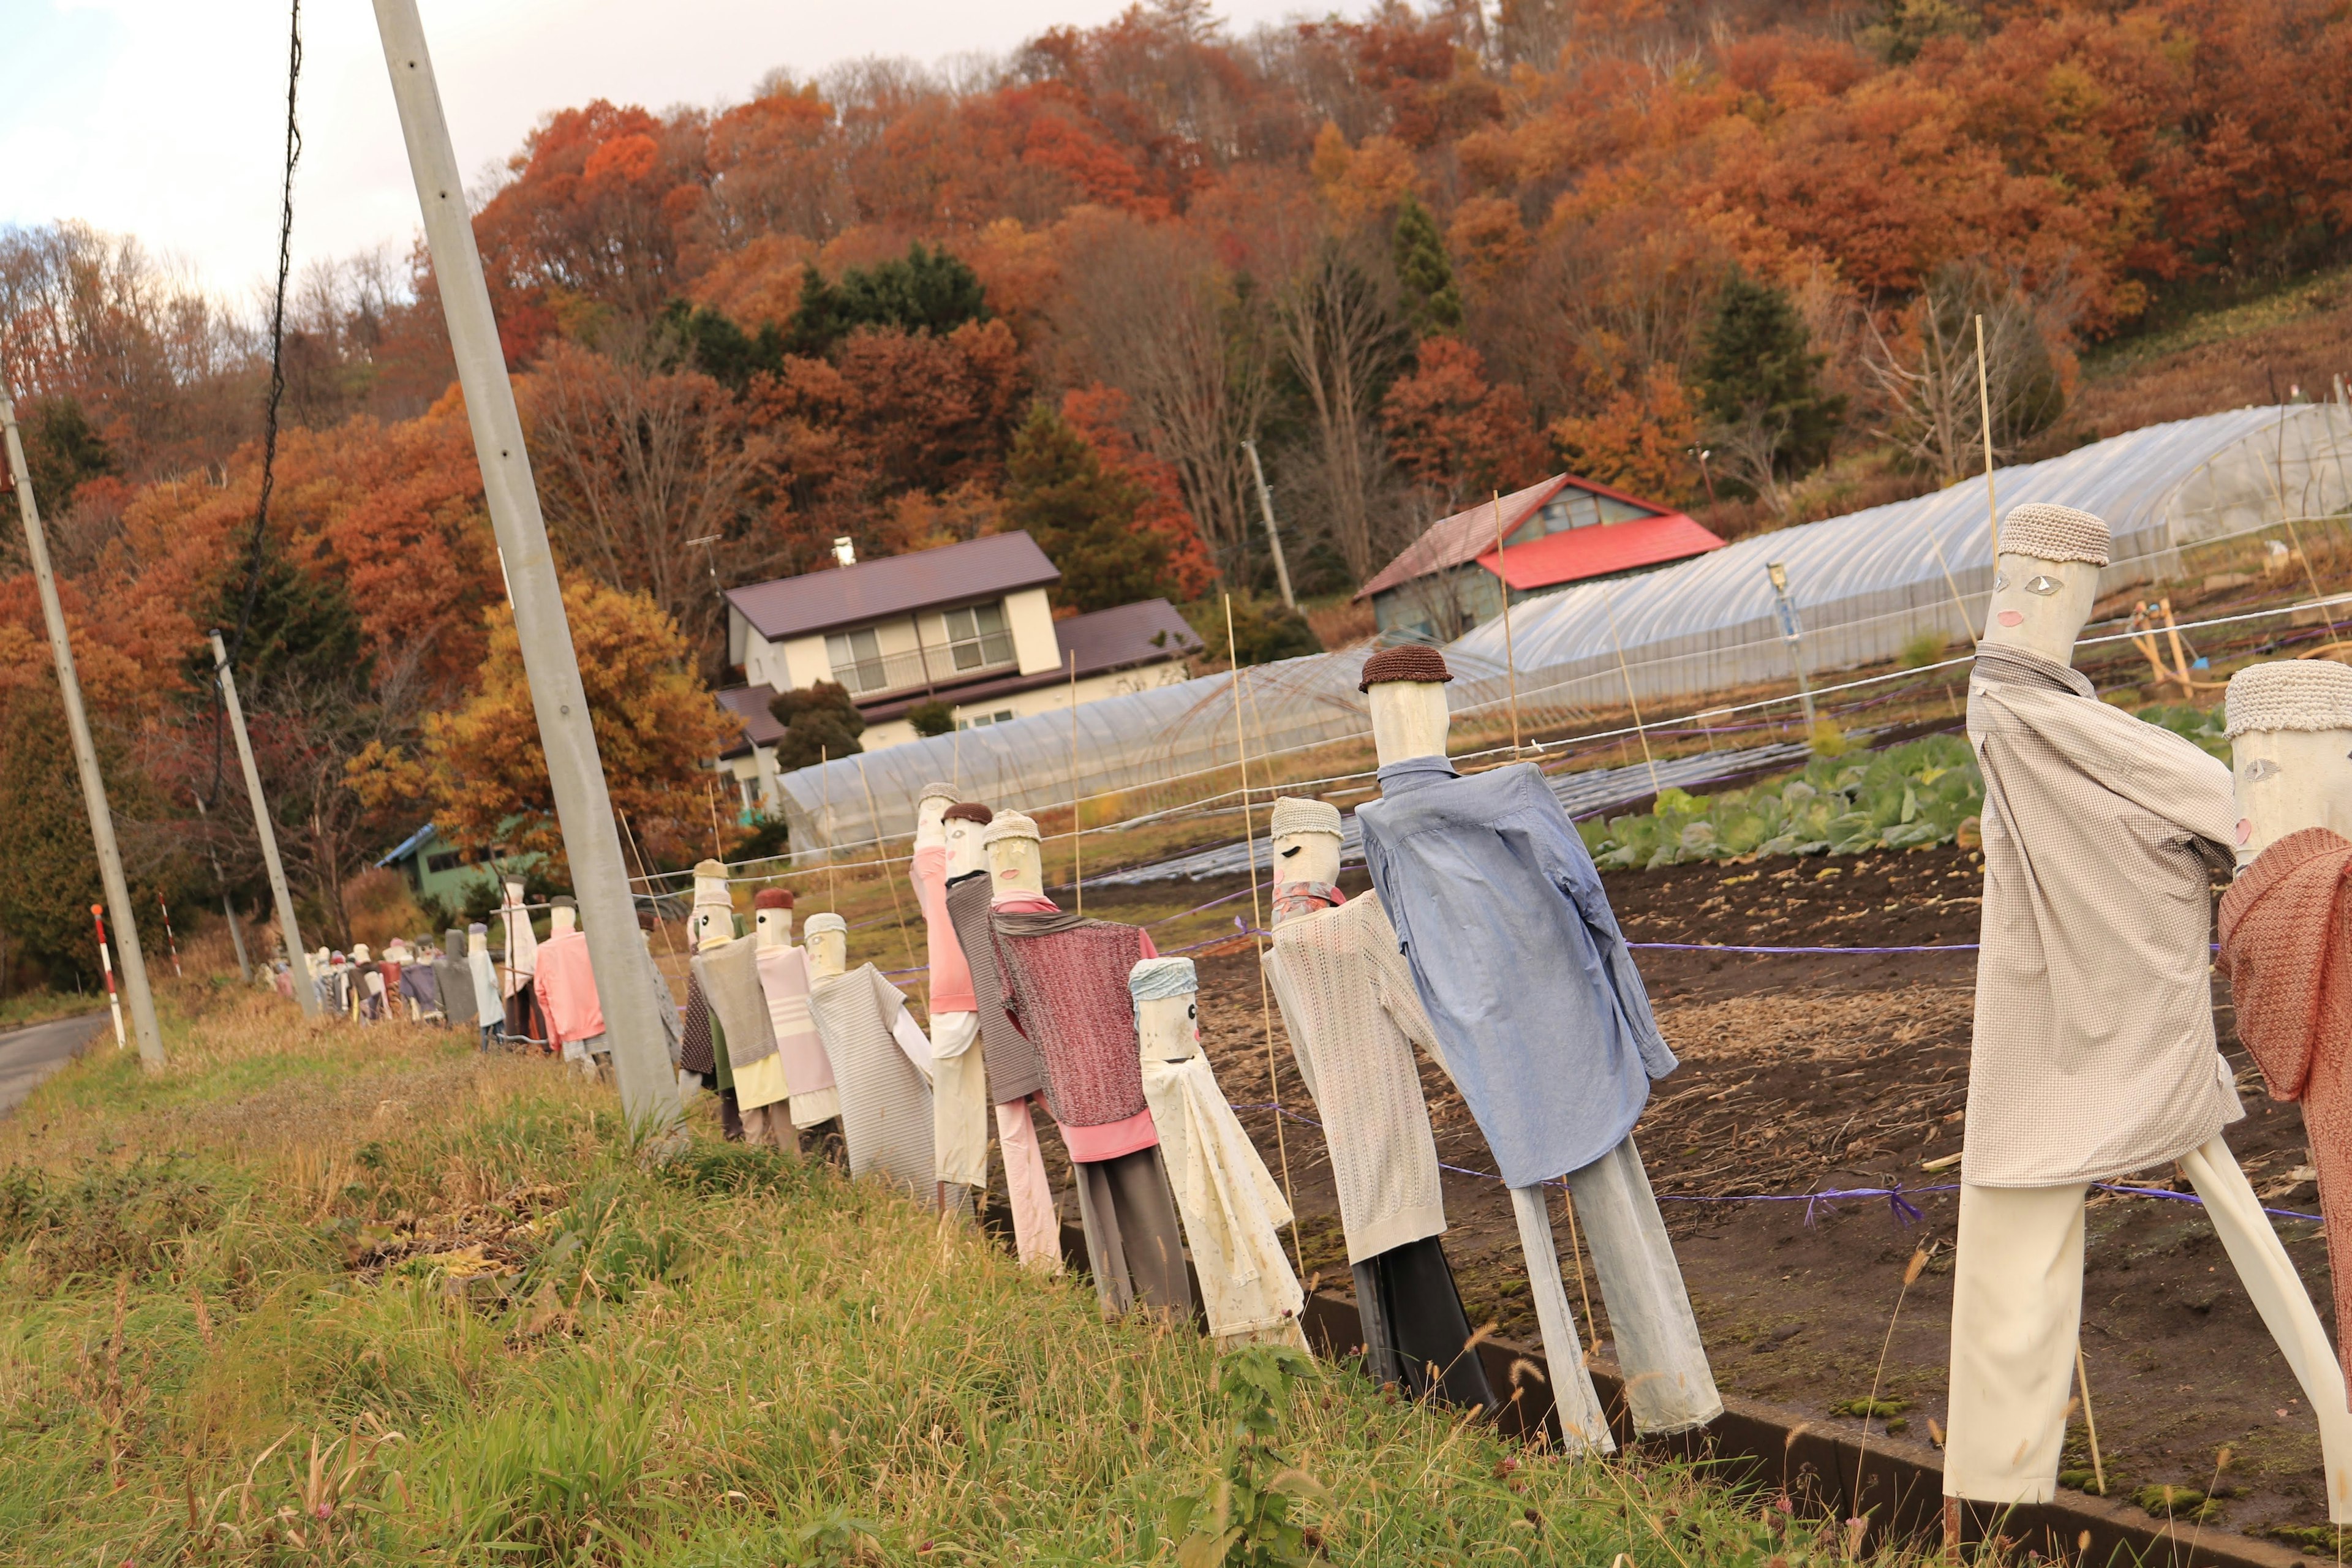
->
[1056, 849, 2333, 1542]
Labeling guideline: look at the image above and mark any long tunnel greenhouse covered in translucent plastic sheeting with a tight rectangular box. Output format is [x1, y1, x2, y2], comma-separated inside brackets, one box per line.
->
[778, 404, 2352, 861]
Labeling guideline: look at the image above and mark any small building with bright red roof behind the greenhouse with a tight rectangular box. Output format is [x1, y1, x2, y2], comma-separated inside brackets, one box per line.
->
[1355, 475, 1724, 642]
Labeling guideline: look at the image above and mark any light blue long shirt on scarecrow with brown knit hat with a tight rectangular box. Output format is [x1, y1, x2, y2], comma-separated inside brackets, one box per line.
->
[1357, 757, 1675, 1187]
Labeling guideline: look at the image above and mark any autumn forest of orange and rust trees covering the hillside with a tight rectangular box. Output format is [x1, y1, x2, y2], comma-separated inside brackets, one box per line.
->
[0, 0, 2352, 978]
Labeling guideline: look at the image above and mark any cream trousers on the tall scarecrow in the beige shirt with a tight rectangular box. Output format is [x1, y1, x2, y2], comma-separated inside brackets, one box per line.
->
[1943, 1138, 2352, 1523]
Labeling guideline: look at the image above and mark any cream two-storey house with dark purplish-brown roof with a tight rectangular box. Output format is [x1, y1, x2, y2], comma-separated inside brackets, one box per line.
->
[720, 533, 1199, 811]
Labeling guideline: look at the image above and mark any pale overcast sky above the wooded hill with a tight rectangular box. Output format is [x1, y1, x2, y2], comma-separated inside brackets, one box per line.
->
[0, 0, 1326, 296]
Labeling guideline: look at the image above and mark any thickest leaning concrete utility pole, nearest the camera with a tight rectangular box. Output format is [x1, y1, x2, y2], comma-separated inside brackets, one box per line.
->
[374, 0, 677, 1128]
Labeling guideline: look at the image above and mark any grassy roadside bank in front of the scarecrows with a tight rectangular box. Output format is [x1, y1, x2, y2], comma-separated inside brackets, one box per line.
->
[0, 995, 1900, 1568]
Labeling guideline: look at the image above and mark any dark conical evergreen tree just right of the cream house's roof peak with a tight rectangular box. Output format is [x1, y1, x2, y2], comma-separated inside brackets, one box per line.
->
[1005, 402, 1174, 611]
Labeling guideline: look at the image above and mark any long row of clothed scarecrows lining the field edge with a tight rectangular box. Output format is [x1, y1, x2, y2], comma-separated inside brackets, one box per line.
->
[298, 505, 2352, 1523]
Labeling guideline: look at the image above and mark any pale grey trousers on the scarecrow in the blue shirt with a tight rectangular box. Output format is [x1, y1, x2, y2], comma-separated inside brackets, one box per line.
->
[1510, 1133, 1724, 1453]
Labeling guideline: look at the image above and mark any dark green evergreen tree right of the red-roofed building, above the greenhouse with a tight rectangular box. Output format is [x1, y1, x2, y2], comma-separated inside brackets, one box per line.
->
[1698, 273, 1846, 477]
